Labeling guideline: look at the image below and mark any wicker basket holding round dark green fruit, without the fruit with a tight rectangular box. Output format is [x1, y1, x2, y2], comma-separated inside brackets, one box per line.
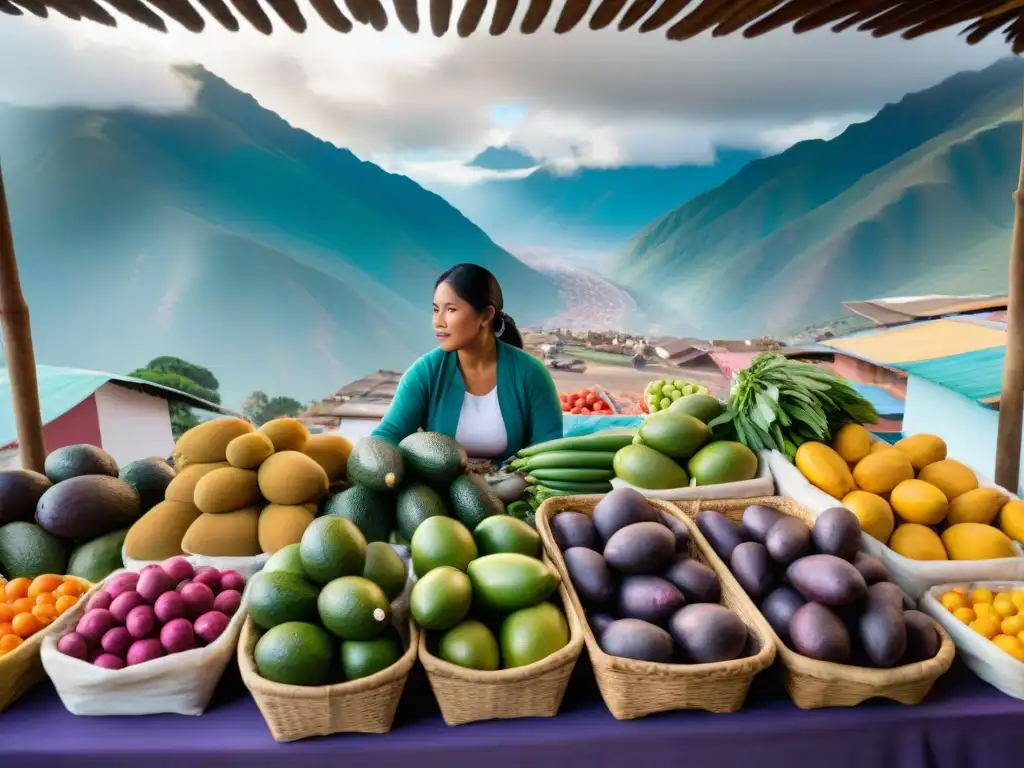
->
[239, 616, 419, 741]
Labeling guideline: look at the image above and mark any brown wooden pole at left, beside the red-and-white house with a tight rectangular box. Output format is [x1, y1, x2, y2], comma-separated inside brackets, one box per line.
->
[0, 162, 46, 472]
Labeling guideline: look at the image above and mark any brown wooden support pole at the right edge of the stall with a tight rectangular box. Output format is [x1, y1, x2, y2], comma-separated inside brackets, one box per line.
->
[995, 93, 1024, 493]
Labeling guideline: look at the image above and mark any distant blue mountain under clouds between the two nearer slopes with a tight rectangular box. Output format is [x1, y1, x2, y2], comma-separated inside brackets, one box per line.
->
[428, 146, 760, 252]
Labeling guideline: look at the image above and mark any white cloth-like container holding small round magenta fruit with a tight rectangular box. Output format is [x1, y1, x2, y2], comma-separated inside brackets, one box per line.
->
[40, 558, 249, 716]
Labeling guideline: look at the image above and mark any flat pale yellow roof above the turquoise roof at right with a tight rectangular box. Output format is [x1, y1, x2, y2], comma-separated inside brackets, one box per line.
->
[822, 318, 1007, 367]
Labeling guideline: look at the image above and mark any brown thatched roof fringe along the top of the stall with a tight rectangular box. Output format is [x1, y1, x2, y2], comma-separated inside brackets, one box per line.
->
[6, 0, 1024, 53]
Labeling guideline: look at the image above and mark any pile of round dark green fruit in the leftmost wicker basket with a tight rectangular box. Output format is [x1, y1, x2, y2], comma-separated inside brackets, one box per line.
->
[249, 515, 407, 686]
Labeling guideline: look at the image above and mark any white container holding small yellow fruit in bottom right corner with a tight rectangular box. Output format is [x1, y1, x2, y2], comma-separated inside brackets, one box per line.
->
[919, 582, 1024, 698]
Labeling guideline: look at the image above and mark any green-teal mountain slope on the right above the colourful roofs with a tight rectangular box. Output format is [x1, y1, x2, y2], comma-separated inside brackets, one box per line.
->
[610, 58, 1024, 338]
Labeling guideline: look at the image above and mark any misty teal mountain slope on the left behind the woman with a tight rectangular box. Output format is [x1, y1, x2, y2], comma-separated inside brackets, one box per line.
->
[0, 69, 562, 408]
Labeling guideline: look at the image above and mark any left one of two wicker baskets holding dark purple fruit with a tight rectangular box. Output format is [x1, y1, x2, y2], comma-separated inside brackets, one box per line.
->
[537, 496, 775, 720]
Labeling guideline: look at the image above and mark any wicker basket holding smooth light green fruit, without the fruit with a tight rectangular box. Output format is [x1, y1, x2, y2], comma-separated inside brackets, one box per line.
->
[420, 558, 583, 725]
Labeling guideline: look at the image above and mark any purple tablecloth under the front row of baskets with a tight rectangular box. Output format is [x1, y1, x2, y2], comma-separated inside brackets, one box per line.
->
[0, 656, 1024, 768]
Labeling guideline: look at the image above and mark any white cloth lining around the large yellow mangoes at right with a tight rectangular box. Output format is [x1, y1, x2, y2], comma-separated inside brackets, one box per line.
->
[768, 451, 1024, 600]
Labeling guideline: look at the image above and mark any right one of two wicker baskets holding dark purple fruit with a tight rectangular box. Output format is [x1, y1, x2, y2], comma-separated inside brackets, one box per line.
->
[675, 497, 955, 710]
